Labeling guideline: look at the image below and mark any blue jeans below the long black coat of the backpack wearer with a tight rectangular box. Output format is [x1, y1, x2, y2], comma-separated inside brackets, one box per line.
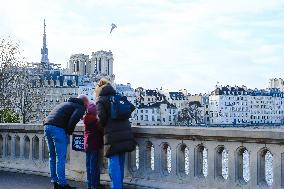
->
[108, 153, 125, 189]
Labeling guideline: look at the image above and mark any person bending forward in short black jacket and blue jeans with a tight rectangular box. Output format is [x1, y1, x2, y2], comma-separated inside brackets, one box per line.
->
[44, 95, 89, 189]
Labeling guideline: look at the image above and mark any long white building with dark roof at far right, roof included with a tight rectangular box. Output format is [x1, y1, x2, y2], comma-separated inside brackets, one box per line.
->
[209, 86, 284, 125]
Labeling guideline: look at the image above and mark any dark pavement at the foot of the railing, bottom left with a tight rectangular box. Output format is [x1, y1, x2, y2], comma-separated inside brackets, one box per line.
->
[0, 171, 86, 189]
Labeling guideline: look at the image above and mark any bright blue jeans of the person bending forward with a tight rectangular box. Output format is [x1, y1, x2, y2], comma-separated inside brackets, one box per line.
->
[44, 125, 69, 186]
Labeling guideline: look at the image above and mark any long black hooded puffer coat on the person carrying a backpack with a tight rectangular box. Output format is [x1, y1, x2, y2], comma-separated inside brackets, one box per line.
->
[96, 84, 136, 157]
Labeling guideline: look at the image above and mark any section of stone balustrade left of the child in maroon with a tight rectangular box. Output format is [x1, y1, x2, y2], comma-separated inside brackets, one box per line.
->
[0, 124, 85, 181]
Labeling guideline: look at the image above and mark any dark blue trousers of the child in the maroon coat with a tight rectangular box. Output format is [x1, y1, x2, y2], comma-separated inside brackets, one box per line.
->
[86, 150, 101, 188]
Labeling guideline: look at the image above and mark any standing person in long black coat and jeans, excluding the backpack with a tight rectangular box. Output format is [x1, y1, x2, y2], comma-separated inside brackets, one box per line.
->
[95, 80, 136, 189]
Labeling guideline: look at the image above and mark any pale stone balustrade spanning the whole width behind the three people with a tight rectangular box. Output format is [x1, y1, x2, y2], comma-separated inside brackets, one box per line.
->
[0, 124, 284, 189]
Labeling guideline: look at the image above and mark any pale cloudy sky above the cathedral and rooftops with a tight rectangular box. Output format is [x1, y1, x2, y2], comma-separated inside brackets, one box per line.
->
[0, 0, 284, 93]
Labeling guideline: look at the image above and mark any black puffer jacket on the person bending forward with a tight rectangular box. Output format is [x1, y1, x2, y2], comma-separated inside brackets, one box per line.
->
[44, 98, 85, 135]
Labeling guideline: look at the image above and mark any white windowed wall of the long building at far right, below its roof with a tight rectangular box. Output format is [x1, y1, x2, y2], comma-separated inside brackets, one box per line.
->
[209, 95, 284, 125]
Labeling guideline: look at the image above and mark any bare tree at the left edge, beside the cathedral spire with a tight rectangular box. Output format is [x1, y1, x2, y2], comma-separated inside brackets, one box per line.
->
[0, 39, 44, 123]
